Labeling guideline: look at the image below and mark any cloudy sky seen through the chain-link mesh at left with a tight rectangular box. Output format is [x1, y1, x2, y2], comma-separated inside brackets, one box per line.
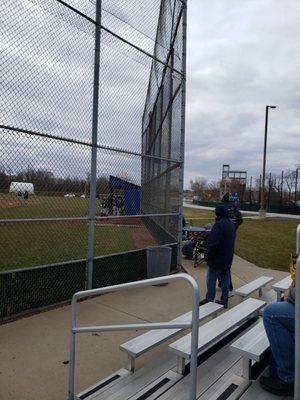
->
[0, 0, 158, 183]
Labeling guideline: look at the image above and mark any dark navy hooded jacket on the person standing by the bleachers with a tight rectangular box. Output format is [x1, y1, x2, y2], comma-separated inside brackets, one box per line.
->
[204, 206, 235, 270]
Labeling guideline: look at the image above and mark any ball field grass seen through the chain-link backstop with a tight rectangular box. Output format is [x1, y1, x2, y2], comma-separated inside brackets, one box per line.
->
[0, 195, 134, 270]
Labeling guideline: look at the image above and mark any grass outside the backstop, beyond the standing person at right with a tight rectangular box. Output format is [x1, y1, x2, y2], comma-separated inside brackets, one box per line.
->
[184, 208, 300, 271]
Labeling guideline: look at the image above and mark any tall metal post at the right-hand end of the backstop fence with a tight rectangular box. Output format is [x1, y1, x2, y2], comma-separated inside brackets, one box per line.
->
[177, 0, 186, 272]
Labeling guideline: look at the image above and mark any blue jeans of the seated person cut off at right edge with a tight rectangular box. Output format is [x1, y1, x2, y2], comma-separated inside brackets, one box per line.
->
[263, 301, 295, 383]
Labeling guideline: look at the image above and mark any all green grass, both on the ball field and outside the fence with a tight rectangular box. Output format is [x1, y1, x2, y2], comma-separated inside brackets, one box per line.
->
[0, 195, 299, 271]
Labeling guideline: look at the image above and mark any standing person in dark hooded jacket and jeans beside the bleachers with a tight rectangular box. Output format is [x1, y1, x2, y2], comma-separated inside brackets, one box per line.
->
[204, 206, 236, 308]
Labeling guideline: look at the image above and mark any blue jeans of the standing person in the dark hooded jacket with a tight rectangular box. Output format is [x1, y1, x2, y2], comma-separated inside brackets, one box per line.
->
[206, 266, 230, 307]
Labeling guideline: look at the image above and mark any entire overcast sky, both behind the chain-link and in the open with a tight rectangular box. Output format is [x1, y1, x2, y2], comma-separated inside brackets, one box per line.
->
[0, 0, 300, 188]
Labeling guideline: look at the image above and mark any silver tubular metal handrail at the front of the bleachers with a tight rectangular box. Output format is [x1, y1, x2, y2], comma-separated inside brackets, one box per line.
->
[68, 273, 200, 400]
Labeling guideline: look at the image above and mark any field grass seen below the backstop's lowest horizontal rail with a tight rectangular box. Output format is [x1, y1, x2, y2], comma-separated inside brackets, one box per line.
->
[0, 222, 134, 270]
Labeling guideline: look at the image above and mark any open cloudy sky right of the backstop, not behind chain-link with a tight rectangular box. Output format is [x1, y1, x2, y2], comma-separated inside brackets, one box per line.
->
[185, 0, 300, 187]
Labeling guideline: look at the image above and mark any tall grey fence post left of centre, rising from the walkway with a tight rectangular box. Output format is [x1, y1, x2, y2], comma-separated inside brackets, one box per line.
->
[87, 0, 102, 289]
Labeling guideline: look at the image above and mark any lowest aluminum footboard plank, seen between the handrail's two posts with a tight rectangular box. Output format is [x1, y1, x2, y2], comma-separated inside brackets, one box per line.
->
[89, 353, 176, 400]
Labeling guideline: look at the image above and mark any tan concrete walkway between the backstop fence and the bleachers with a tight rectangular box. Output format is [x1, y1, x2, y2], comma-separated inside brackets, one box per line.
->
[0, 257, 287, 400]
